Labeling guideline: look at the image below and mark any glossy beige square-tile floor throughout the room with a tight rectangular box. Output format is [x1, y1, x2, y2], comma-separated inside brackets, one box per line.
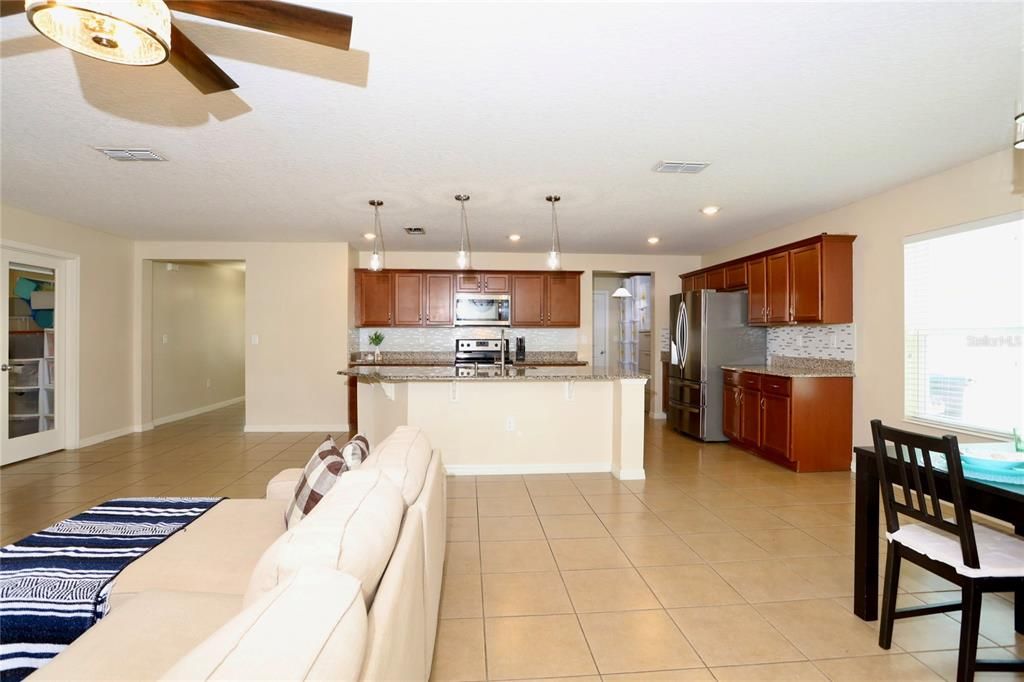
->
[0, 406, 1024, 682]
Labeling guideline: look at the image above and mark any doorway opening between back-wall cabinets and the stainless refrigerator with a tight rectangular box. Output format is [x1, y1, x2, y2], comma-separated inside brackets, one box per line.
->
[593, 271, 654, 414]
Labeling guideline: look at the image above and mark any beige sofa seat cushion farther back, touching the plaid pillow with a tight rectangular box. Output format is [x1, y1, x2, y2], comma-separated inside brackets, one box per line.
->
[111, 493, 285, 609]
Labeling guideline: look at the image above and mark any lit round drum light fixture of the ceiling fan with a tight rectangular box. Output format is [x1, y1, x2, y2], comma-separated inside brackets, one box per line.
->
[25, 0, 171, 67]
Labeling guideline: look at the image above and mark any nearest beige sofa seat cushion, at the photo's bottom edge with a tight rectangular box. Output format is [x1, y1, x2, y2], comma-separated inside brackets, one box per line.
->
[29, 592, 242, 682]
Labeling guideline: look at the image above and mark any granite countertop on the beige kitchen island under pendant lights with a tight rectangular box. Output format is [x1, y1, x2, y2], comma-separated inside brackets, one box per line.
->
[338, 366, 649, 383]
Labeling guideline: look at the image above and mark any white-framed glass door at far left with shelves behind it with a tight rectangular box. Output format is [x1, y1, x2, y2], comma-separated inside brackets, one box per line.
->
[0, 248, 68, 464]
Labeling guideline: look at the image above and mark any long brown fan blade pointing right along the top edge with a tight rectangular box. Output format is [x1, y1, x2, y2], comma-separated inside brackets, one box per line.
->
[166, 0, 352, 50]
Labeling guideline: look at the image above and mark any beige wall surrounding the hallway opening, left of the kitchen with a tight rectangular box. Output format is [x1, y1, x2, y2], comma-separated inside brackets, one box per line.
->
[132, 242, 351, 431]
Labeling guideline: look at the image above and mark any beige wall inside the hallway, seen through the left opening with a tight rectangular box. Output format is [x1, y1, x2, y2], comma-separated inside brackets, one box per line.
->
[151, 262, 246, 424]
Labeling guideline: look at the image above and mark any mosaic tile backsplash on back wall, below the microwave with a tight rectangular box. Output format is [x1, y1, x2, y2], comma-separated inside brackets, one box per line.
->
[349, 327, 580, 352]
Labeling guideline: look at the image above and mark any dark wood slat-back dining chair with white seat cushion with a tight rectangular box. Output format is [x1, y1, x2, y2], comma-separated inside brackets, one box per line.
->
[871, 419, 1024, 682]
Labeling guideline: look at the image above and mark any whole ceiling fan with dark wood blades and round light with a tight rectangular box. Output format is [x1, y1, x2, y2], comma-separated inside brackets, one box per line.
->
[0, 0, 352, 94]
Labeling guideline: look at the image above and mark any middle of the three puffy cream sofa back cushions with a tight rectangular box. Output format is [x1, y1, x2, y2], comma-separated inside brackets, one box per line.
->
[245, 469, 404, 606]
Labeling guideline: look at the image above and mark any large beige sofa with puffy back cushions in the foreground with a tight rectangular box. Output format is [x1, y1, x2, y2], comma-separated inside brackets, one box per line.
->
[31, 427, 445, 680]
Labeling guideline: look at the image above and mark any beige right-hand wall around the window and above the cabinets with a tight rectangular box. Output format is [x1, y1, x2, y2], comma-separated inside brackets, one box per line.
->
[702, 150, 1024, 443]
